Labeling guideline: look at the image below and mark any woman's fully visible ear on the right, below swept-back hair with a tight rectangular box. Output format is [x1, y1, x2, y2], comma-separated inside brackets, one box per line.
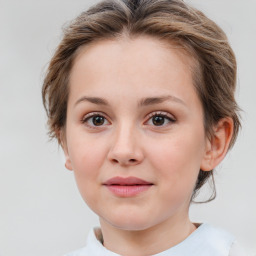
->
[200, 117, 234, 171]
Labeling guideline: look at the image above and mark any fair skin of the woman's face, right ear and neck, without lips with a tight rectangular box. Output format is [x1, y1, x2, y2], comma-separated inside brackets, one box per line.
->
[62, 37, 233, 256]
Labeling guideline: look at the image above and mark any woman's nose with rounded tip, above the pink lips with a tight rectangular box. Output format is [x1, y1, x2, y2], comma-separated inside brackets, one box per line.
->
[108, 125, 144, 166]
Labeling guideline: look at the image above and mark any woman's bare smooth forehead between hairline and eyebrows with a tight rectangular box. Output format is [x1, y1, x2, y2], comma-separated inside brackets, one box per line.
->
[69, 36, 201, 107]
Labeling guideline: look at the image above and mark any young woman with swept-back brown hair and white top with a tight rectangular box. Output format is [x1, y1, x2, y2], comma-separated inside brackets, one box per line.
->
[43, 0, 246, 256]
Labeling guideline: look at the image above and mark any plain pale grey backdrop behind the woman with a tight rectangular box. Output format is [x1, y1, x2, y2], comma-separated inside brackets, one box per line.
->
[0, 0, 256, 256]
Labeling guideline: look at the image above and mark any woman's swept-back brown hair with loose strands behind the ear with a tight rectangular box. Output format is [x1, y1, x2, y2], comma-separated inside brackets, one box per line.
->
[42, 0, 240, 201]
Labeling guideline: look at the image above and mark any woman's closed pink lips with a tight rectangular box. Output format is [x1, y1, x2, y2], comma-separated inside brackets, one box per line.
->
[103, 177, 153, 197]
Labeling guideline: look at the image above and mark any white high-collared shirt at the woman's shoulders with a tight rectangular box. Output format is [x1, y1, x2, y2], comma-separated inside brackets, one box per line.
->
[65, 224, 246, 256]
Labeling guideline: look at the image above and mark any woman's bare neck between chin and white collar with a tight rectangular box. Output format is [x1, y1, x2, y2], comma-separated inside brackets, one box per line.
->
[100, 216, 196, 256]
